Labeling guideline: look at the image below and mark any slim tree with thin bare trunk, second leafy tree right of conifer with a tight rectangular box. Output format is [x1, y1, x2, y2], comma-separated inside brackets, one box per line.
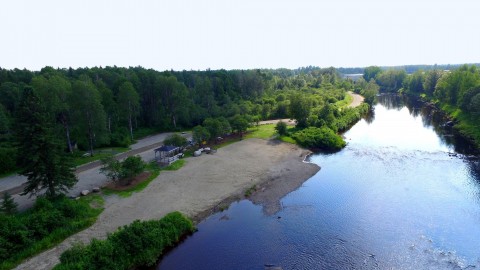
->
[117, 82, 140, 141]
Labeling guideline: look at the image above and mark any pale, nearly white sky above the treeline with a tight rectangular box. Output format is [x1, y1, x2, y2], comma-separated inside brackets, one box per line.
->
[0, 0, 480, 70]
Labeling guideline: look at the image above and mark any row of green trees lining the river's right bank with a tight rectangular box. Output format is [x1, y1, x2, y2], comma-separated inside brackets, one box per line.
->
[355, 65, 480, 147]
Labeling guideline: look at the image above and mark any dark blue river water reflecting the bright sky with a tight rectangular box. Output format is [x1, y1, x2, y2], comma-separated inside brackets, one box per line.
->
[157, 96, 480, 270]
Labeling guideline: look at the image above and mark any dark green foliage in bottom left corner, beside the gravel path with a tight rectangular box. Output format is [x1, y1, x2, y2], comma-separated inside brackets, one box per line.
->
[0, 196, 102, 269]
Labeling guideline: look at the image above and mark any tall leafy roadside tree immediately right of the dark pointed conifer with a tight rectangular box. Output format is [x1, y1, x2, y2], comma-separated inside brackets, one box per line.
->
[70, 77, 108, 156]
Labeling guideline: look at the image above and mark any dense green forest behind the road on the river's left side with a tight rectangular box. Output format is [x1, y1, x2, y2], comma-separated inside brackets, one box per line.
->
[0, 67, 368, 173]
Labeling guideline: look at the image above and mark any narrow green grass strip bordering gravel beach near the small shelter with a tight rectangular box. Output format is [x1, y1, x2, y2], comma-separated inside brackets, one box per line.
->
[102, 159, 186, 198]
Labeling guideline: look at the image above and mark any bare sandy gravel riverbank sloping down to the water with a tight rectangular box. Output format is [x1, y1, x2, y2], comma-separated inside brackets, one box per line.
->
[16, 139, 319, 269]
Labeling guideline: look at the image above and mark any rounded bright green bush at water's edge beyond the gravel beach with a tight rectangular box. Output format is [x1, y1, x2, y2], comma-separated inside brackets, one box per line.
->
[292, 127, 346, 151]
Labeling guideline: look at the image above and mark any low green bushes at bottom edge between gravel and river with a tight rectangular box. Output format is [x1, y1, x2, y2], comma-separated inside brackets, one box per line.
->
[54, 212, 195, 270]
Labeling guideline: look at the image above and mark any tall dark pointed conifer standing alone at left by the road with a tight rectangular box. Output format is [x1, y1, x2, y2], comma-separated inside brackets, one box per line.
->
[16, 87, 77, 197]
